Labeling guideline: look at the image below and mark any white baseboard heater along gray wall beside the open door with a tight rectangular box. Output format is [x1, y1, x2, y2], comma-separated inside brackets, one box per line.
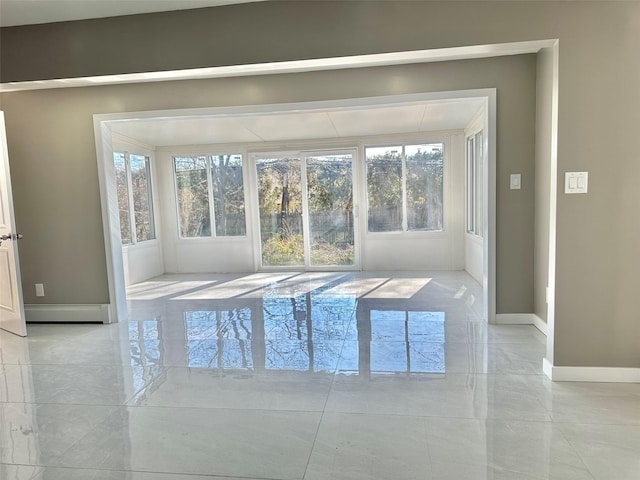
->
[24, 304, 111, 323]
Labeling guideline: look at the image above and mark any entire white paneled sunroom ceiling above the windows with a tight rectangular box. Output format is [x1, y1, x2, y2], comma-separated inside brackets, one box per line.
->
[110, 99, 483, 147]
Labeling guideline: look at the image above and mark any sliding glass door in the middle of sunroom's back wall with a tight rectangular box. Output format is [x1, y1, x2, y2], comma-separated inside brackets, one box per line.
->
[254, 150, 357, 270]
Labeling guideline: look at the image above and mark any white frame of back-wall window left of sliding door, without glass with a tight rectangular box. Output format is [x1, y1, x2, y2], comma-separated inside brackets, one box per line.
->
[171, 153, 248, 242]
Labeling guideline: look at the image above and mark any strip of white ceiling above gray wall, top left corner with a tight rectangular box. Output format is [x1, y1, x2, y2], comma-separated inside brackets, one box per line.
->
[0, 0, 260, 27]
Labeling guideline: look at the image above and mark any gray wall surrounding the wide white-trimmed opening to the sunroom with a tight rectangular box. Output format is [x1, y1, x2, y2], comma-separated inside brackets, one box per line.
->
[1, 55, 536, 312]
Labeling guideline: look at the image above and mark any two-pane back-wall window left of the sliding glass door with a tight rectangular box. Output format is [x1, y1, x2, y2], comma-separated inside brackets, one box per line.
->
[173, 154, 247, 238]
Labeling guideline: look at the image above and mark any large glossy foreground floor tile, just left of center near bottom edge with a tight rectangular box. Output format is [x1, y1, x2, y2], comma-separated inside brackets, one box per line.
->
[57, 407, 320, 479]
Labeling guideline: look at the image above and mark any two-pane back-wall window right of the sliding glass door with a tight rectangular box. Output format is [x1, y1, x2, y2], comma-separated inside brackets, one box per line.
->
[365, 143, 444, 232]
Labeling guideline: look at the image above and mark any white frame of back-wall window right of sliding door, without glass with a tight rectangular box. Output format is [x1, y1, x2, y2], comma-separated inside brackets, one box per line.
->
[362, 141, 450, 236]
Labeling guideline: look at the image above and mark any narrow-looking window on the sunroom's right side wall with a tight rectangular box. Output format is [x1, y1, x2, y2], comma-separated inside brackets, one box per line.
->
[467, 131, 484, 237]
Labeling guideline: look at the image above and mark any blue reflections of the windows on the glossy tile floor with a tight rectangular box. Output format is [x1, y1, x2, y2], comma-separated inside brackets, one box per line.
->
[129, 292, 445, 375]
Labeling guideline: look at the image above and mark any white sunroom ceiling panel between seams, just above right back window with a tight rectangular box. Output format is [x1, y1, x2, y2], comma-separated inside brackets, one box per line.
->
[329, 105, 425, 137]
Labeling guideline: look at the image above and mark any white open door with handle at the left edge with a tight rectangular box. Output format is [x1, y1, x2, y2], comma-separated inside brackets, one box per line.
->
[0, 111, 27, 337]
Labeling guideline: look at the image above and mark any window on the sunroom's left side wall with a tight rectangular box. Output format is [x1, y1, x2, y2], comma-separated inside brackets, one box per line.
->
[113, 152, 156, 245]
